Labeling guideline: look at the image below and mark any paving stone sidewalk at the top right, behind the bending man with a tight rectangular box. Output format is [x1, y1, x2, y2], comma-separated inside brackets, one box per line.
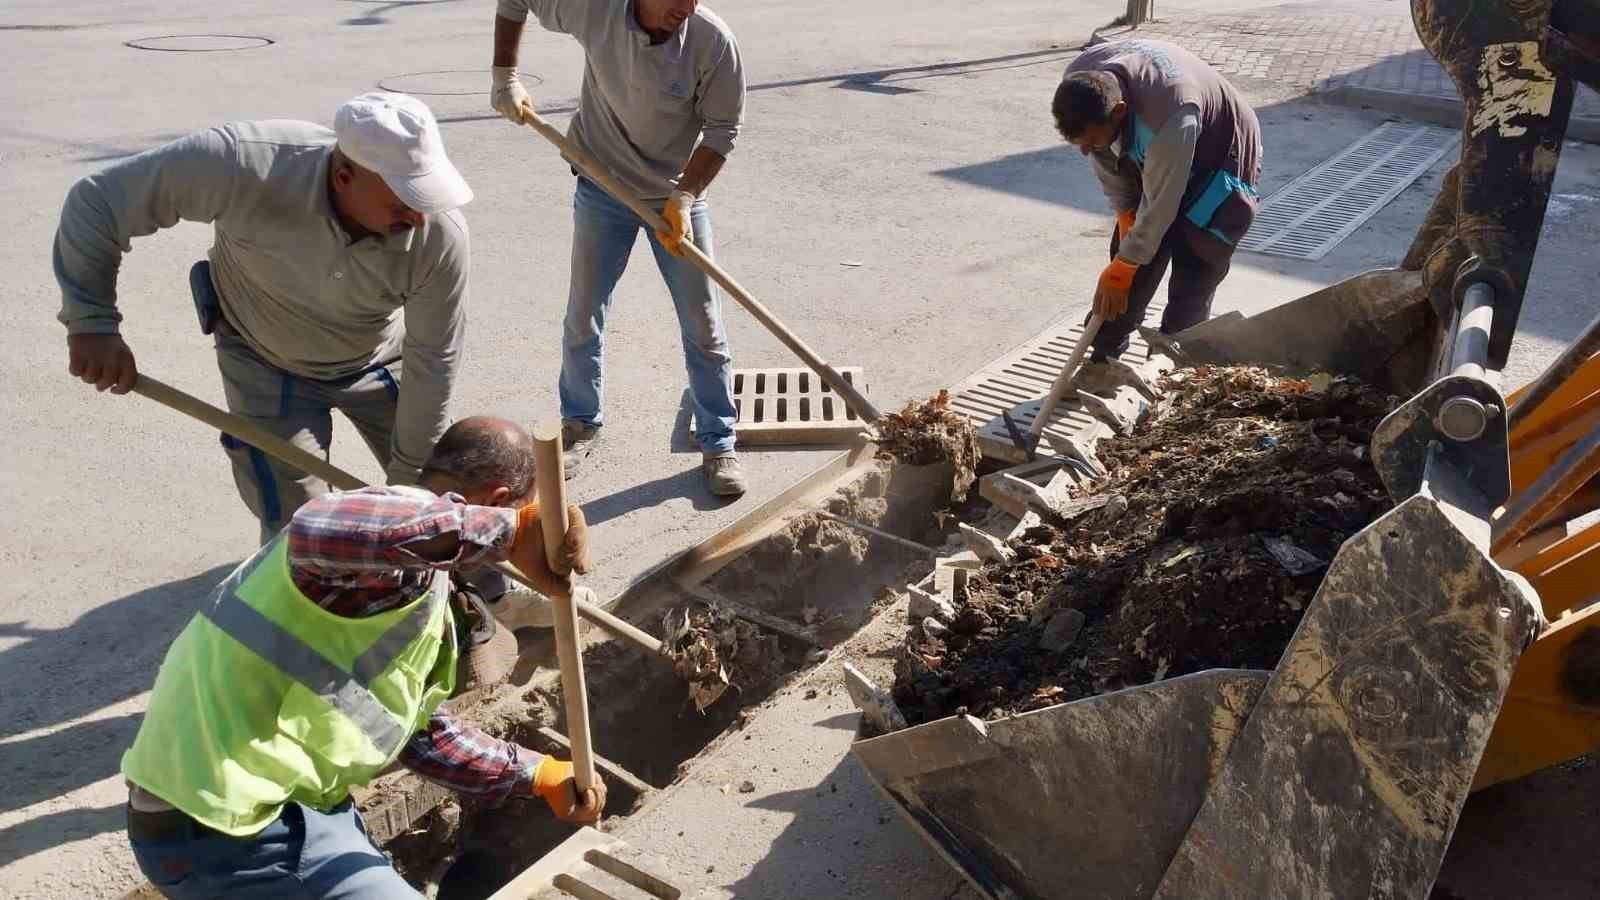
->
[1102, 0, 1600, 128]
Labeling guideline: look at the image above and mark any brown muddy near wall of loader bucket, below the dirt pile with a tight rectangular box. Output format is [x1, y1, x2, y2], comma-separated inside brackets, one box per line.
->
[853, 669, 1266, 900]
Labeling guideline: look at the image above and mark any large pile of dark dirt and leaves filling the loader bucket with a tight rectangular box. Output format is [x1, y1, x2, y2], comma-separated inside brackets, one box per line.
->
[894, 367, 1397, 724]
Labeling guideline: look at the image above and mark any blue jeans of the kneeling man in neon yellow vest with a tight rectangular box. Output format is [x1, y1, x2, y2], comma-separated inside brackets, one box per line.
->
[130, 801, 421, 900]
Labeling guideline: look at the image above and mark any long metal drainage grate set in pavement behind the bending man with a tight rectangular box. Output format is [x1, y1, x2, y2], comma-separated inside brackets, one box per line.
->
[1238, 122, 1461, 259]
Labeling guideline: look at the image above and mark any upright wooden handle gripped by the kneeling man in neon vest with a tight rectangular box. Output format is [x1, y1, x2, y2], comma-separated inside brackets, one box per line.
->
[533, 421, 595, 791]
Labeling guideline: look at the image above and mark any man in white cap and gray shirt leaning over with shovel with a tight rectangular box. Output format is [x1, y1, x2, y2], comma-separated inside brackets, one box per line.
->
[54, 93, 472, 544]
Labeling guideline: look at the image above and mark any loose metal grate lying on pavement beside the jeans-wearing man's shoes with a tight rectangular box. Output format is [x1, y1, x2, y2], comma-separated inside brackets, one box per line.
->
[713, 367, 867, 444]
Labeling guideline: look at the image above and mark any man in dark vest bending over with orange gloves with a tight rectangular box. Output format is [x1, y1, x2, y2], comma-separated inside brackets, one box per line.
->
[1051, 40, 1261, 362]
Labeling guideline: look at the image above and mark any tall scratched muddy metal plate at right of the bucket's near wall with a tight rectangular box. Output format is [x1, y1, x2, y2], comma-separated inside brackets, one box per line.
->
[1157, 495, 1536, 900]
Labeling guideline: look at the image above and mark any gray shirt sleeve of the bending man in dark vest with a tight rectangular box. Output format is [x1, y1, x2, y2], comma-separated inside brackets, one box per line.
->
[1091, 104, 1200, 266]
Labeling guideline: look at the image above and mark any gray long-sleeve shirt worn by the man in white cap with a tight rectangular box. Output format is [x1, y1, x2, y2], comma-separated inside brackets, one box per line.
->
[54, 120, 469, 482]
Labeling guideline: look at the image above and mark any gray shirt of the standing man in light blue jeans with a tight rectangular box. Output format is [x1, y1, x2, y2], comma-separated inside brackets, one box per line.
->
[498, 0, 744, 200]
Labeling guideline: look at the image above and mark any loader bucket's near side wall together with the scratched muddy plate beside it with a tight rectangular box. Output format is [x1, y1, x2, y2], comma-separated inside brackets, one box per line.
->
[853, 493, 1536, 900]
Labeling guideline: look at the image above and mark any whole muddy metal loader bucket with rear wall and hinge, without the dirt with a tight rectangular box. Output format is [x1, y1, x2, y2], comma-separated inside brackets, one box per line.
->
[854, 257, 1561, 900]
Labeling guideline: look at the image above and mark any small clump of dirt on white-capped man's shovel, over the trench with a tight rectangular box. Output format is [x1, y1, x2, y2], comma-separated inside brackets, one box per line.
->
[661, 604, 792, 713]
